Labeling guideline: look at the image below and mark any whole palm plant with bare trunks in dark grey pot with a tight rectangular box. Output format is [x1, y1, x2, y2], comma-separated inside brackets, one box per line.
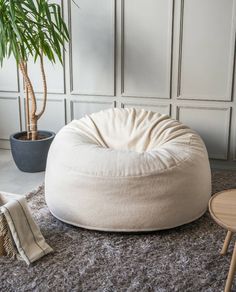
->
[0, 0, 69, 172]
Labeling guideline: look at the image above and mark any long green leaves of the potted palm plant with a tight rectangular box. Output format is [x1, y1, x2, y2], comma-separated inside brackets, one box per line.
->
[0, 0, 70, 65]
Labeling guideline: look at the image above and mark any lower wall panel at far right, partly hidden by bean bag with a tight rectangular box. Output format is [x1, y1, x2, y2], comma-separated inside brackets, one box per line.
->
[178, 106, 231, 159]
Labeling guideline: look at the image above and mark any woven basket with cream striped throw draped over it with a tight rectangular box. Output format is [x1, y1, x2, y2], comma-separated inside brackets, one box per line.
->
[0, 193, 52, 265]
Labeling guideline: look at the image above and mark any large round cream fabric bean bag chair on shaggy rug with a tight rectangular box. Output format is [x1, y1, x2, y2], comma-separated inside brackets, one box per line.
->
[45, 109, 211, 231]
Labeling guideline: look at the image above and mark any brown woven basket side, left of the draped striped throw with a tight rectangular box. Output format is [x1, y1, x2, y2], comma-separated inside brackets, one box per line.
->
[0, 212, 17, 258]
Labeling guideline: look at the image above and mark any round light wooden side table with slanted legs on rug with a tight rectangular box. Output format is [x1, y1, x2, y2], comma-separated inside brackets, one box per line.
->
[209, 189, 236, 292]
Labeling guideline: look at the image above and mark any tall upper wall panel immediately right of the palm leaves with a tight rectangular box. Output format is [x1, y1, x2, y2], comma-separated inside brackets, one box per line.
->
[70, 0, 115, 95]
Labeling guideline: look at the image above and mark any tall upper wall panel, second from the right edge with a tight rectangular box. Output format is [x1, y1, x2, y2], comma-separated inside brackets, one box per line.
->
[122, 0, 173, 98]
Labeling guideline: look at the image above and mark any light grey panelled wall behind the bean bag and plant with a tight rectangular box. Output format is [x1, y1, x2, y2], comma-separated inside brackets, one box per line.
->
[0, 0, 236, 167]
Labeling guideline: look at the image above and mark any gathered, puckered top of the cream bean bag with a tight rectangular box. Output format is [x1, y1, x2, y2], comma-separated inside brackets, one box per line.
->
[52, 108, 207, 177]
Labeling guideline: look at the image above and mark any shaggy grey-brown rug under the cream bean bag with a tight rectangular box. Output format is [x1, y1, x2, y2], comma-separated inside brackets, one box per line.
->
[0, 171, 236, 292]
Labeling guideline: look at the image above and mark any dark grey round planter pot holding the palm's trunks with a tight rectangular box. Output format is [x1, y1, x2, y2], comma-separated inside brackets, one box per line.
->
[10, 131, 55, 172]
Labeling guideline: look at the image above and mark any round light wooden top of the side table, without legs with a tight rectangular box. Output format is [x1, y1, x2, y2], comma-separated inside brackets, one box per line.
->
[209, 189, 236, 232]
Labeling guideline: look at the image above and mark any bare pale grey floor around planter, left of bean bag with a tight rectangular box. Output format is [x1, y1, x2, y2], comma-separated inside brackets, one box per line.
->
[0, 149, 44, 195]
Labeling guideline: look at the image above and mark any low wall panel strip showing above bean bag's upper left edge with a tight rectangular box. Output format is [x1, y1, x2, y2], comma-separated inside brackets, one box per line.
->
[71, 100, 115, 119]
